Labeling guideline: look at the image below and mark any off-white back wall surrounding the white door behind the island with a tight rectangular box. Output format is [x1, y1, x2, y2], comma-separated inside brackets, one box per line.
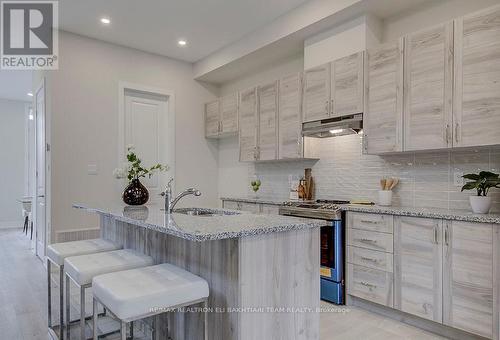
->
[47, 32, 218, 240]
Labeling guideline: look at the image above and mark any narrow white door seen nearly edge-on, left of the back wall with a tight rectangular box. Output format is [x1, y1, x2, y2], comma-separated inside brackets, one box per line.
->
[34, 83, 47, 260]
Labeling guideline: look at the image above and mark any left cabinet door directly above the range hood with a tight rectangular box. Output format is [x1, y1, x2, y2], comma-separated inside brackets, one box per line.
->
[302, 63, 330, 122]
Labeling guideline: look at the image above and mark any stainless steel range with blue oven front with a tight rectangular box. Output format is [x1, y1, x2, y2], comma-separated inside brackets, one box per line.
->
[279, 200, 349, 305]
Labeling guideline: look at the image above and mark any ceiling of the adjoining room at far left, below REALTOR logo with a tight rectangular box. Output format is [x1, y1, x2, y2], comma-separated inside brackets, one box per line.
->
[0, 70, 32, 101]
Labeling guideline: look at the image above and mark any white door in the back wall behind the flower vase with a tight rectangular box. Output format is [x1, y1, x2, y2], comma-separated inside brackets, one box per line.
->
[124, 90, 169, 202]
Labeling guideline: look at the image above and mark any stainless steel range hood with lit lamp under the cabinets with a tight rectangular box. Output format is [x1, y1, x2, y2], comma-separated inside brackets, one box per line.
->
[302, 113, 363, 138]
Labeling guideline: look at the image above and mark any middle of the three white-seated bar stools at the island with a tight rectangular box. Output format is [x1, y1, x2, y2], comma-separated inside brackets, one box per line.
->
[64, 249, 153, 340]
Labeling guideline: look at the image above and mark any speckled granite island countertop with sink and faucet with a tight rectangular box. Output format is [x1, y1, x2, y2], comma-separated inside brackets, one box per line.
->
[73, 204, 325, 241]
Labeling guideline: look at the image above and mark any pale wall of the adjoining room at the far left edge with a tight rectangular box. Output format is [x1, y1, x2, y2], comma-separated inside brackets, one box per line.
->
[0, 99, 27, 227]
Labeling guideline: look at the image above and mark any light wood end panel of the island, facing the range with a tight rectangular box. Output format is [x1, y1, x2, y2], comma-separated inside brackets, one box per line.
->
[239, 228, 320, 340]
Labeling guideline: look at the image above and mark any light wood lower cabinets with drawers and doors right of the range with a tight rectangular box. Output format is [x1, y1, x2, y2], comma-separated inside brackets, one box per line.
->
[347, 212, 500, 340]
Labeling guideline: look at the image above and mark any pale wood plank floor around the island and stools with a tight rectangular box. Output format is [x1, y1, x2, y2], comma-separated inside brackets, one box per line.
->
[0, 229, 444, 340]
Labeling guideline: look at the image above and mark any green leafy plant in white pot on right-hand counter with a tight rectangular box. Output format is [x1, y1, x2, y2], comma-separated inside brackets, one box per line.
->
[462, 171, 500, 214]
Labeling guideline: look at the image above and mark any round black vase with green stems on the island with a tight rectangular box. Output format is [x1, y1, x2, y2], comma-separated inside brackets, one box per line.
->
[114, 146, 168, 205]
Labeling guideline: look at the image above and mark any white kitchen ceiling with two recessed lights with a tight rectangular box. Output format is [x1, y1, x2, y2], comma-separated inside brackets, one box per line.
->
[59, 0, 308, 62]
